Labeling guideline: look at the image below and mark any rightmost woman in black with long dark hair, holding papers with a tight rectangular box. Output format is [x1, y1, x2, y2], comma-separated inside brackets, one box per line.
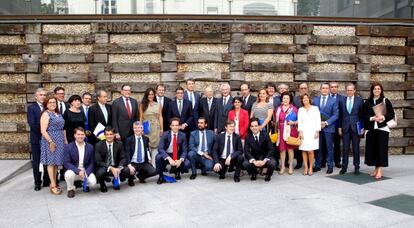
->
[363, 82, 395, 180]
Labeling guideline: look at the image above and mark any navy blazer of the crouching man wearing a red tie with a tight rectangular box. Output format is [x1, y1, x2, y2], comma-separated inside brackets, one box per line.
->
[158, 130, 187, 160]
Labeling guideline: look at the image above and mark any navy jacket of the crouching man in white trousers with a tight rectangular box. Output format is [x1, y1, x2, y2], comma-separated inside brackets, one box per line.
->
[63, 141, 95, 175]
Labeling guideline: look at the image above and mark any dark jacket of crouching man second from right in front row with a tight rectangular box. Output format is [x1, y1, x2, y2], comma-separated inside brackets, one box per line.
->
[213, 133, 243, 163]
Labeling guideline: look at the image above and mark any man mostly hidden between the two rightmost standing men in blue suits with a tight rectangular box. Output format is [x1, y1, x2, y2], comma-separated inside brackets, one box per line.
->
[329, 82, 344, 168]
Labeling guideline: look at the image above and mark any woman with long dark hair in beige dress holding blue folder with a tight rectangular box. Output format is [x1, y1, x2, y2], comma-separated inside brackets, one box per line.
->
[139, 88, 164, 166]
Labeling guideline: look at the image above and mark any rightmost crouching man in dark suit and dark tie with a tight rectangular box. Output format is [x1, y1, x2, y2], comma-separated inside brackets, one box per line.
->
[243, 118, 276, 181]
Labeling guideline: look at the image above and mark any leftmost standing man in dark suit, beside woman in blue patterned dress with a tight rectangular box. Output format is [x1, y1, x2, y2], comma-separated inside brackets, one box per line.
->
[27, 88, 50, 191]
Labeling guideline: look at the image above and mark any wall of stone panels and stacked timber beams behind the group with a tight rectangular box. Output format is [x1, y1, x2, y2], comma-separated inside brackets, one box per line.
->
[0, 21, 414, 159]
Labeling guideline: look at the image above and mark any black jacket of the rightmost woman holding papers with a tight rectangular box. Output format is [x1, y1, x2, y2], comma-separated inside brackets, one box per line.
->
[362, 96, 395, 130]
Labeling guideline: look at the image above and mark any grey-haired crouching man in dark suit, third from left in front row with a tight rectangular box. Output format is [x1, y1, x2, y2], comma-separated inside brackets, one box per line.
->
[125, 121, 157, 183]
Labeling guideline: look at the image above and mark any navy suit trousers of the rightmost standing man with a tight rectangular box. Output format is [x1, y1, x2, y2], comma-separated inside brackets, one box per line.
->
[342, 129, 360, 169]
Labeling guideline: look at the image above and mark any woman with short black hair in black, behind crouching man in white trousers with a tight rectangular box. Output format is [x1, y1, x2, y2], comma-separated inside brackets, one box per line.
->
[63, 95, 86, 143]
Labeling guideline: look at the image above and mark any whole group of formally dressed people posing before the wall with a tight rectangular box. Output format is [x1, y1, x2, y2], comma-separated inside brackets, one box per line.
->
[27, 79, 395, 198]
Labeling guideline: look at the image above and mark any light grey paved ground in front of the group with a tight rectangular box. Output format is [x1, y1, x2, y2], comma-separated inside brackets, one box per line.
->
[0, 156, 414, 228]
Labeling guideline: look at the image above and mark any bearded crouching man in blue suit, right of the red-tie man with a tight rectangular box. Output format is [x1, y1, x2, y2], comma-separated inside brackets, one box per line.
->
[188, 117, 214, 180]
